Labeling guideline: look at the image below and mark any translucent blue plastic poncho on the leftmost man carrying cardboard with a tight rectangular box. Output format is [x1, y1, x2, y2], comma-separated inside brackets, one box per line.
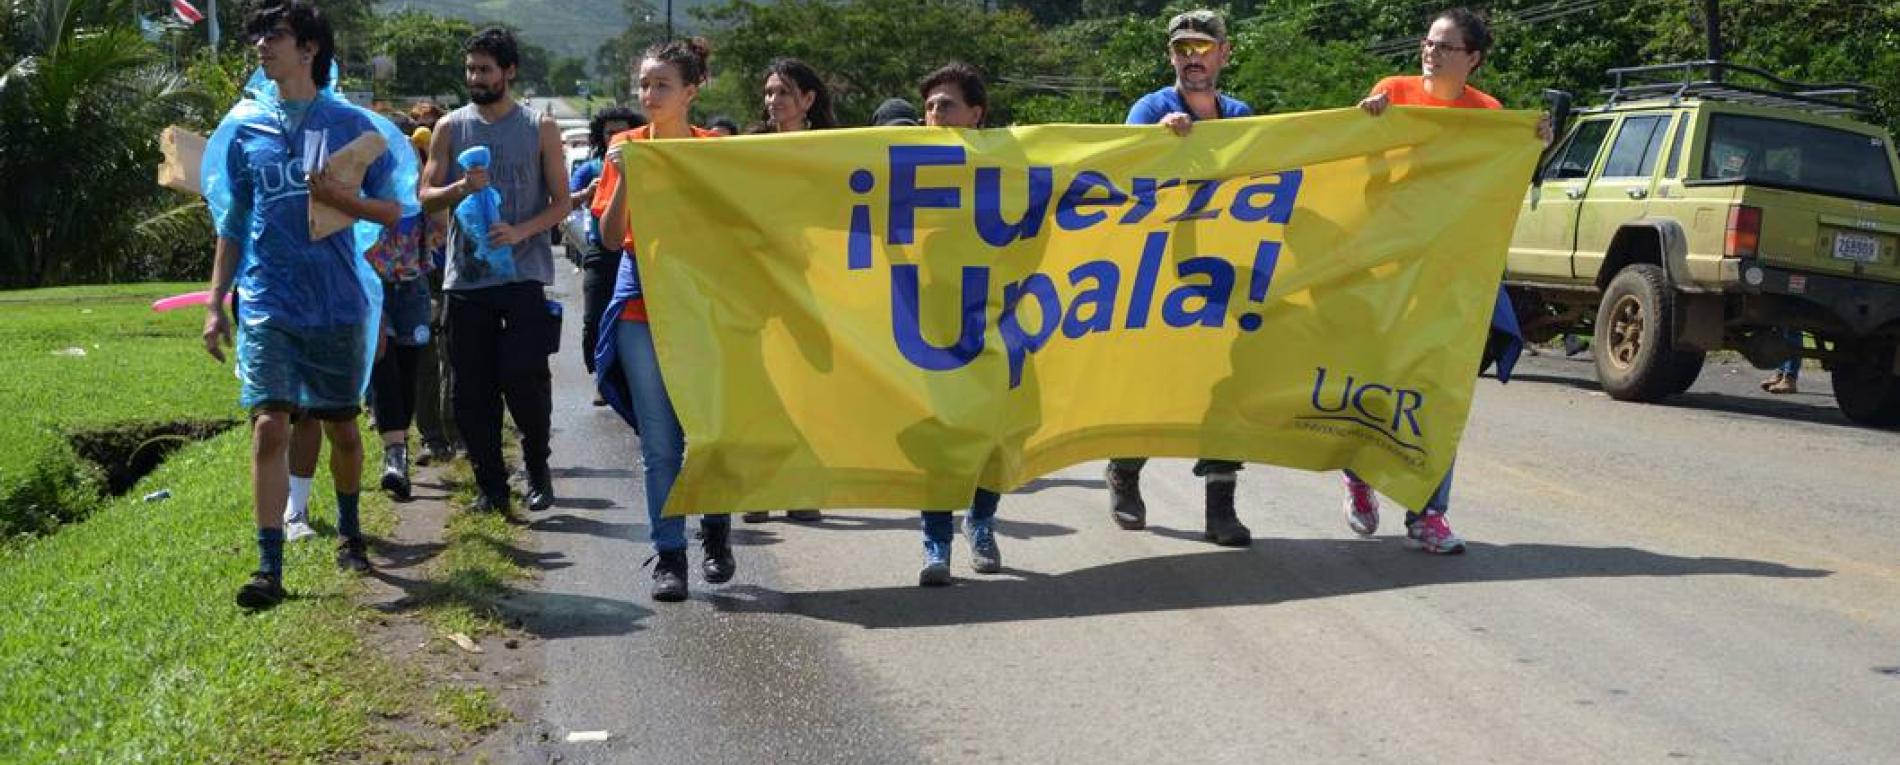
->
[200, 66, 422, 406]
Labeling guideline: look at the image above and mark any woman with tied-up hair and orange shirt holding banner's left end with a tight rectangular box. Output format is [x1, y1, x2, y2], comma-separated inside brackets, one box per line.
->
[591, 38, 735, 602]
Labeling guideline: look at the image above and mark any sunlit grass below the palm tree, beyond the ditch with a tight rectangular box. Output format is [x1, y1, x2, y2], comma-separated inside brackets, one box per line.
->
[0, 285, 241, 537]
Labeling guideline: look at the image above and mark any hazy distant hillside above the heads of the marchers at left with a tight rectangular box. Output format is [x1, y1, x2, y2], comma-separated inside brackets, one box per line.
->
[376, 0, 737, 68]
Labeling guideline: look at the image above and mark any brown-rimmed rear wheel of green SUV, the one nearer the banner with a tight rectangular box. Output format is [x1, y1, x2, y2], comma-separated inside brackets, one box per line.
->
[1596, 264, 1706, 401]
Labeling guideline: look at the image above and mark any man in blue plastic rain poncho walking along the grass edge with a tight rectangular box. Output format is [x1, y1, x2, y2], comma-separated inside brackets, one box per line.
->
[203, 0, 420, 609]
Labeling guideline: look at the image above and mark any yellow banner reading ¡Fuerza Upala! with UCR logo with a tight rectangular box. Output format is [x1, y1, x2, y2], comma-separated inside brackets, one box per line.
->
[623, 108, 1539, 514]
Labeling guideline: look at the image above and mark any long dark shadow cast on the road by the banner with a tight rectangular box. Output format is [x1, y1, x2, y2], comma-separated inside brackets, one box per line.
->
[722, 539, 1834, 628]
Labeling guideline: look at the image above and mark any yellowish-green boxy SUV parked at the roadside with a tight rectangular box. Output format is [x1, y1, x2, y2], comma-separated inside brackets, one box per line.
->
[1505, 61, 1900, 425]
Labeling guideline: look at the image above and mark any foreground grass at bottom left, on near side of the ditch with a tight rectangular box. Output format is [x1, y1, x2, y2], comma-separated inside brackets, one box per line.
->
[0, 429, 422, 763]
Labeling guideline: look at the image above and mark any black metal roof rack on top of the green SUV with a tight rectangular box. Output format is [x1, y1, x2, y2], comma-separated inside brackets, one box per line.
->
[1604, 61, 1873, 118]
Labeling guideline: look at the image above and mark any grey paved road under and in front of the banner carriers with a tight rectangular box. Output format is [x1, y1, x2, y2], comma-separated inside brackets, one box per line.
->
[505, 261, 1900, 763]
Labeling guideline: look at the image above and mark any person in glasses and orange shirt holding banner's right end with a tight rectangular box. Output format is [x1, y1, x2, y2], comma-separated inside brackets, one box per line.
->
[1345, 8, 1550, 554]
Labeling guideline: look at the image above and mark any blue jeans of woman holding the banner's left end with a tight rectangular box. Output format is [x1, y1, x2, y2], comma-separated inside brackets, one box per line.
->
[616, 321, 732, 552]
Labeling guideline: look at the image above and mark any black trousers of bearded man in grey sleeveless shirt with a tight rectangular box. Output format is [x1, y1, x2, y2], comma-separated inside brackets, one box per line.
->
[445, 281, 559, 499]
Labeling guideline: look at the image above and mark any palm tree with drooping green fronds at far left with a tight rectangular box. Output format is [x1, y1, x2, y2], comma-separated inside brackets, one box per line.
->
[0, 0, 209, 287]
